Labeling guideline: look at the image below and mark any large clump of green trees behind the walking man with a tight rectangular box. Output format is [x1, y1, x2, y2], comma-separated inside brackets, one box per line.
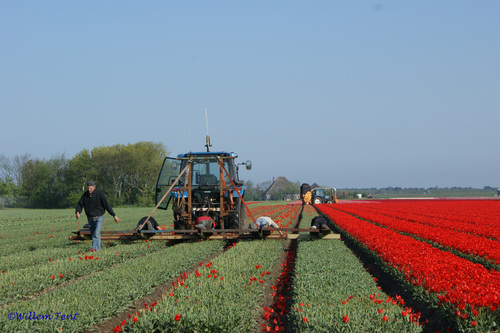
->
[0, 142, 167, 208]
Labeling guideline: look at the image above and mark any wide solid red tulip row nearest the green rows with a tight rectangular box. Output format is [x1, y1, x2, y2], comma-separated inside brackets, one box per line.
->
[319, 205, 500, 329]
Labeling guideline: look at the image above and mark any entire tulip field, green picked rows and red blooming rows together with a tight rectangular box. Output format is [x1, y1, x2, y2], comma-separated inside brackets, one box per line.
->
[0, 199, 500, 332]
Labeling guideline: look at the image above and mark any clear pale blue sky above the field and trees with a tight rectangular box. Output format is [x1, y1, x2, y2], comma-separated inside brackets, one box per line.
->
[0, 0, 500, 188]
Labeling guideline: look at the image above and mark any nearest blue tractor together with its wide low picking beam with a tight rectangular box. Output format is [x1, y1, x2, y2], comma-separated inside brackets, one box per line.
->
[68, 140, 340, 241]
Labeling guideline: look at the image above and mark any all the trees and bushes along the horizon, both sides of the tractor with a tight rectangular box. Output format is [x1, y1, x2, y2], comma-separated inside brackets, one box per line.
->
[0, 142, 497, 208]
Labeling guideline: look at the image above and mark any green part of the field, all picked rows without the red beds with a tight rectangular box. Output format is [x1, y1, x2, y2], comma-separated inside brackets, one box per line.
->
[0, 203, 421, 332]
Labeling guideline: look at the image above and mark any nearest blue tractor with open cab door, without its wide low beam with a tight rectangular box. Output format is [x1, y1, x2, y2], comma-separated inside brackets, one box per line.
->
[156, 144, 252, 230]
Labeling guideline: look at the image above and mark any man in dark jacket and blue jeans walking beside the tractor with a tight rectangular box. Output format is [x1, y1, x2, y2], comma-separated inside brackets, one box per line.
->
[76, 181, 120, 251]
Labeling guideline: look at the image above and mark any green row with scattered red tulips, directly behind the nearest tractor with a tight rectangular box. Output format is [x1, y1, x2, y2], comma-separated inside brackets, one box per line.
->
[119, 241, 283, 332]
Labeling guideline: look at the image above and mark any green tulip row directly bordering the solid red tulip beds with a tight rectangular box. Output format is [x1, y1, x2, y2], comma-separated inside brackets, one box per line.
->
[290, 240, 422, 332]
